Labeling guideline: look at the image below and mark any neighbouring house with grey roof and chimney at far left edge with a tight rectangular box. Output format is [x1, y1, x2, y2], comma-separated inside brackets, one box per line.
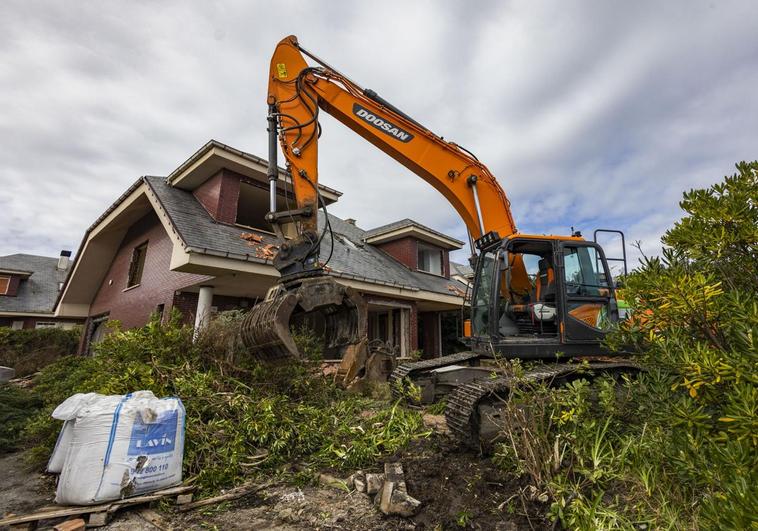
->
[0, 251, 84, 330]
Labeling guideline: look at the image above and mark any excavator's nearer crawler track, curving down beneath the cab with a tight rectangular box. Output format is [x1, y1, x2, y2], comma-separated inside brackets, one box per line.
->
[445, 360, 641, 450]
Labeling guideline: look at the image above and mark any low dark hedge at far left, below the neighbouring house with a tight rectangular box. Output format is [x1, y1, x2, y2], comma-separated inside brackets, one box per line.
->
[0, 327, 82, 377]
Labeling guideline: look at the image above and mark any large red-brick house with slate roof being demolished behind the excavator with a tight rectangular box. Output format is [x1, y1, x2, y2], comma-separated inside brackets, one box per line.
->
[56, 140, 465, 356]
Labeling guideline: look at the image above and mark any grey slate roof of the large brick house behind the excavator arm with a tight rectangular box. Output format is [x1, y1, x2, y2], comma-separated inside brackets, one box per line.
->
[143, 177, 465, 296]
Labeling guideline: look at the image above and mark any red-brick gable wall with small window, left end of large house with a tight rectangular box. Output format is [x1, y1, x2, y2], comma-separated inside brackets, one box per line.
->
[90, 212, 212, 328]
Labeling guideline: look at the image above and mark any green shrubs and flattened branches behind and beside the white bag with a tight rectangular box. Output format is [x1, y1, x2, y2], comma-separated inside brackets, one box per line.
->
[14, 315, 426, 493]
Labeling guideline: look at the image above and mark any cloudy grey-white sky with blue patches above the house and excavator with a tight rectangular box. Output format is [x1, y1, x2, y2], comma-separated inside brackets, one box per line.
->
[0, 0, 758, 270]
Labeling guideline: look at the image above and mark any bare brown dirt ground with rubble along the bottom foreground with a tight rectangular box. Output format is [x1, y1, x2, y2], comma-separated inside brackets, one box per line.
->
[0, 435, 549, 531]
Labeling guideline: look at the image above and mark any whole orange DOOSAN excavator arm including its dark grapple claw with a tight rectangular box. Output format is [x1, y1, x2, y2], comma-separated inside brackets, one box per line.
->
[242, 36, 529, 370]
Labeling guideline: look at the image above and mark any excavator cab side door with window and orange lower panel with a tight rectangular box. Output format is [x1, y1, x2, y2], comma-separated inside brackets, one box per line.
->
[559, 242, 618, 343]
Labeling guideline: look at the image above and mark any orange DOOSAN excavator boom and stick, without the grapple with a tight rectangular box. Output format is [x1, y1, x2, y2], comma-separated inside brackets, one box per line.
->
[268, 36, 516, 254]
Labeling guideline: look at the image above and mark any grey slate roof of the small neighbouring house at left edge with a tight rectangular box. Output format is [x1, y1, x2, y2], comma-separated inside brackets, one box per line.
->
[0, 254, 67, 314]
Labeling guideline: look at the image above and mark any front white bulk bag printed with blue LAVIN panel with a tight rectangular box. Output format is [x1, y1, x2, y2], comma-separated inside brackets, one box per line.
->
[55, 392, 184, 505]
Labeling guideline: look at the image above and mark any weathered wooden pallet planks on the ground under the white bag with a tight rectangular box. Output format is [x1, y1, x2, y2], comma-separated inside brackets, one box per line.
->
[0, 485, 195, 529]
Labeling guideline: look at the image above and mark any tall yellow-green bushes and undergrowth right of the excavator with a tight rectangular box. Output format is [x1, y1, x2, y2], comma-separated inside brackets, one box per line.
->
[497, 162, 758, 529]
